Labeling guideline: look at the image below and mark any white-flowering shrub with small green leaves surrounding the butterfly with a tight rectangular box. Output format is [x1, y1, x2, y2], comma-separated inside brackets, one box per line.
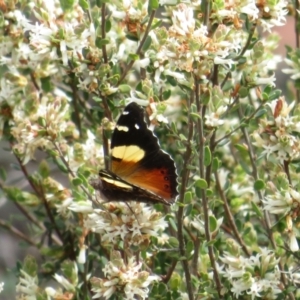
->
[0, 0, 300, 300]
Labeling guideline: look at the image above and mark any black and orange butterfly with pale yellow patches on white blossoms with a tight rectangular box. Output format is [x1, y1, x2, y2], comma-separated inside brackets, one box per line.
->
[92, 102, 178, 205]
